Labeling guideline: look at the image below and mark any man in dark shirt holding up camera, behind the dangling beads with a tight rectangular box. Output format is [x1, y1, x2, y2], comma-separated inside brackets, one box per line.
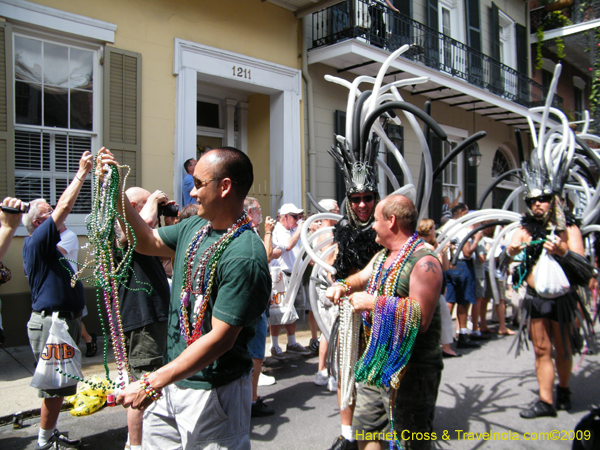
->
[119, 187, 171, 450]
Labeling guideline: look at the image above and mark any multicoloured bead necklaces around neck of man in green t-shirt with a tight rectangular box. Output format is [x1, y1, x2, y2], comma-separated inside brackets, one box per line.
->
[179, 211, 252, 345]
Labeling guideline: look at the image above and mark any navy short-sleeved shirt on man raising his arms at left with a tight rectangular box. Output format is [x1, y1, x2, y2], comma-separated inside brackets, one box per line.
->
[23, 216, 85, 313]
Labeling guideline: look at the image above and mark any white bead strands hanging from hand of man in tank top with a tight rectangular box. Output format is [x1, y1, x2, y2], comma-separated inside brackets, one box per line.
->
[339, 297, 361, 410]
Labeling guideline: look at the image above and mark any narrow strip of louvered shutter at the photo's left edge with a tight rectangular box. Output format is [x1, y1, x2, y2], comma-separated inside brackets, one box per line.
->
[0, 22, 15, 201]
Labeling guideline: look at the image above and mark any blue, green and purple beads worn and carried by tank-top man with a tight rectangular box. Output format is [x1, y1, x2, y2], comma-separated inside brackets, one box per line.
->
[354, 233, 422, 448]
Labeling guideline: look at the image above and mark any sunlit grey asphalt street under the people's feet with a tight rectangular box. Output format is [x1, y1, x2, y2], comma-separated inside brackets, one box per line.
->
[0, 327, 600, 450]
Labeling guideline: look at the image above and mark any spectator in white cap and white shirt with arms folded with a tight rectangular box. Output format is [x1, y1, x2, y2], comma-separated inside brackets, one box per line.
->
[271, 203, 311, 359]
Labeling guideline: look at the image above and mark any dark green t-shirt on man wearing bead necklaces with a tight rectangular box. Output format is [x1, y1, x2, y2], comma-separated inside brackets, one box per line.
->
[158, 216, 271, 390]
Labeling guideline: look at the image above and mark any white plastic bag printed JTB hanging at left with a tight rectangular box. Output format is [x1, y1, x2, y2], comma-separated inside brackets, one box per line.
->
[30, 313, 83, 389]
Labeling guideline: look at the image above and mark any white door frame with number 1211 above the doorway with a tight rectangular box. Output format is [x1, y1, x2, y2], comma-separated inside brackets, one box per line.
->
[173, 39, 302, 214]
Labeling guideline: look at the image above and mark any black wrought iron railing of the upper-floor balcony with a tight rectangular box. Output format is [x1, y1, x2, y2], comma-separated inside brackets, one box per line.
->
[312, 0, 562, 108]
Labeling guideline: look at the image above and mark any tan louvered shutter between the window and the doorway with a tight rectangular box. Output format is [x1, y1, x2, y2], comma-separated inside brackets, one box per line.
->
[103, 46, 142, 188]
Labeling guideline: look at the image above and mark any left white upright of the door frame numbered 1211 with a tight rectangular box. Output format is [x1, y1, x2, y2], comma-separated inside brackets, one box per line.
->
[173, 68, 198, 202]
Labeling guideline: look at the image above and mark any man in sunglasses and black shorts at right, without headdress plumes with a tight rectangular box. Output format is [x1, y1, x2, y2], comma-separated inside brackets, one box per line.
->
[506, 189, 572, 419]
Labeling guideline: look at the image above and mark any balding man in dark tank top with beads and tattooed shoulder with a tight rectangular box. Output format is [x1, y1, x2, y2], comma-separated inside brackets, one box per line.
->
[327, 195, 443, 449]
